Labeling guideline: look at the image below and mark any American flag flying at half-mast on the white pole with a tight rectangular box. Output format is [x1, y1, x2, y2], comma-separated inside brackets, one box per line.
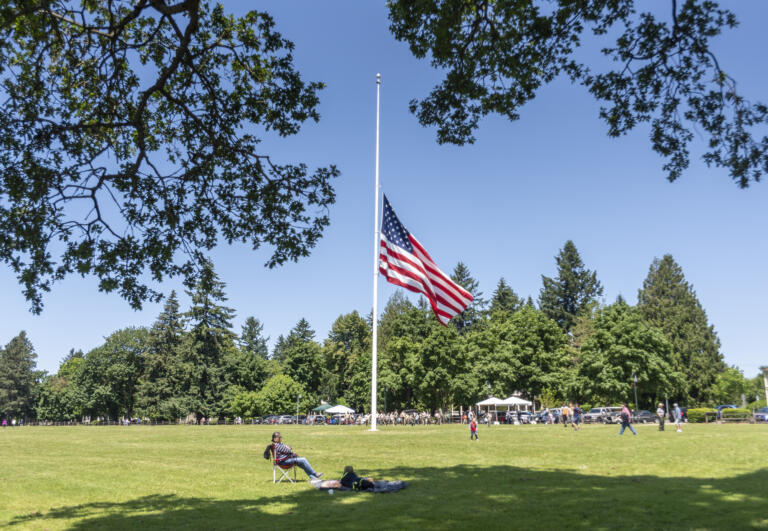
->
[379, 196, 472, 325]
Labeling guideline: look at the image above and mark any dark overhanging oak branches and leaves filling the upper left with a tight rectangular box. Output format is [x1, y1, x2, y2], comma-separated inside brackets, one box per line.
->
[0, 0, 338, 312]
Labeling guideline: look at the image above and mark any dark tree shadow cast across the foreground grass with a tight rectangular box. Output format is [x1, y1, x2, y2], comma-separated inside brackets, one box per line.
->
[8, 465, 768, 530]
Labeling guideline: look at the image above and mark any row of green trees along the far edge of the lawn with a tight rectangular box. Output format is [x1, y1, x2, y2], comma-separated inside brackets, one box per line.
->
[0, 241, 760, 420]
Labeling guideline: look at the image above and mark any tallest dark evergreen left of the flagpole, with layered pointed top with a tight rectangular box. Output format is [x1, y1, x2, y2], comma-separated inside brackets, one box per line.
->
[180, 264, 236, 418]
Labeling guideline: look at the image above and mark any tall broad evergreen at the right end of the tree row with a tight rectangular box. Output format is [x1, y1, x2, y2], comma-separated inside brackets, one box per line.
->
[637, 254, 725, 402]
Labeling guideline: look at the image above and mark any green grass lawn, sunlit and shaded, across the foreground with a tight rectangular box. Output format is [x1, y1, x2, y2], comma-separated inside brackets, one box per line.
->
[0, 425, 768, 529]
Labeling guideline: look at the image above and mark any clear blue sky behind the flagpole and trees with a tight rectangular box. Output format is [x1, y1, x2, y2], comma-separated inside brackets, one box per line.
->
[0, 0, 768, 376]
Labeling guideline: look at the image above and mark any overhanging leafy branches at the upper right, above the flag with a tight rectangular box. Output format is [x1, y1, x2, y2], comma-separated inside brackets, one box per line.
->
[388, 0, 768, 188]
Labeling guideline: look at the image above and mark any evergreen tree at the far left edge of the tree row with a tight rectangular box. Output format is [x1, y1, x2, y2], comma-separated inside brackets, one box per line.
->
[0, 331, 42, 419]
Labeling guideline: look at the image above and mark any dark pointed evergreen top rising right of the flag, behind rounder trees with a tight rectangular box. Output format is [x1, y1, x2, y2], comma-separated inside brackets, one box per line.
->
[539, 240, 603, 332]
